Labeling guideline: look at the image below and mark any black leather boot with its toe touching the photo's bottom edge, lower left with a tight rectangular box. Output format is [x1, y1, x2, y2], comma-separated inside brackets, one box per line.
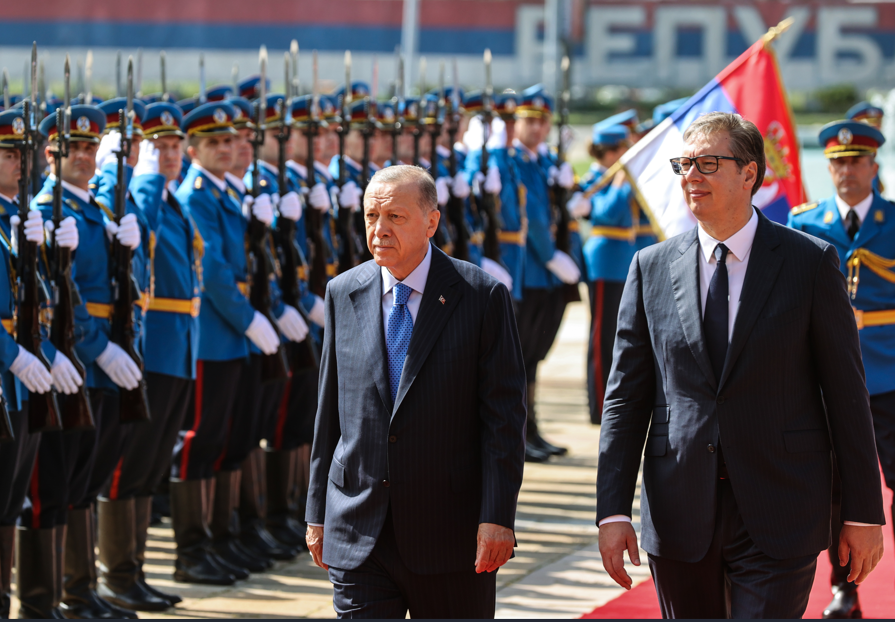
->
[60, 507, 137, 619]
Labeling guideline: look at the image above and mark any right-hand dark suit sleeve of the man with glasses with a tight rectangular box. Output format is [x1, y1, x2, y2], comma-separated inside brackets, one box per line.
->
[810, 246, 886, 525]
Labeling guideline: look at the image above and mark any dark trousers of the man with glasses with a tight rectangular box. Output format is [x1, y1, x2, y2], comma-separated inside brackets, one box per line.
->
[649, 480, 817, 619]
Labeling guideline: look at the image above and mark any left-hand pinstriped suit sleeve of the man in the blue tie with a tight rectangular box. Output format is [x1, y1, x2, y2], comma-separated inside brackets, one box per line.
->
[305, 285, 342, 525]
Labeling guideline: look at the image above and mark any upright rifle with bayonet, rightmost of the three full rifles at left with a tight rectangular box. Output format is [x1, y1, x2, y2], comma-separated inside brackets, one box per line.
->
[110, 57, 150, 423]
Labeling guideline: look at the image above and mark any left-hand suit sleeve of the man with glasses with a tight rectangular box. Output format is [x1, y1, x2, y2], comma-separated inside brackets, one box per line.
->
[597, 253, 656, 524]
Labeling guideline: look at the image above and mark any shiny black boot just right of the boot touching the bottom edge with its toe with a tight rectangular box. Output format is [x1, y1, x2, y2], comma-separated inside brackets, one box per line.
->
[97, 497, 171, 611]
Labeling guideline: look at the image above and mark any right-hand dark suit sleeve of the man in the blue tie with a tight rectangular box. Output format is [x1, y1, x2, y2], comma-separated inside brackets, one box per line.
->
[478, 284, 526, 529]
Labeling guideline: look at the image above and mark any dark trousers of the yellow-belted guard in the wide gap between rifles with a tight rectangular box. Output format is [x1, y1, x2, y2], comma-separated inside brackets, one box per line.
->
[103, 372, 194, 499]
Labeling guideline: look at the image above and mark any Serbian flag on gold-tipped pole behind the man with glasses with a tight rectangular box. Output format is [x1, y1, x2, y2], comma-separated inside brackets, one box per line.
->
[604, 22, 807, 239]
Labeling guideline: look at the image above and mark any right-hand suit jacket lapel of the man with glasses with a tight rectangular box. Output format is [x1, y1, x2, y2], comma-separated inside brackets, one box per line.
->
[718, 212, 783, 389]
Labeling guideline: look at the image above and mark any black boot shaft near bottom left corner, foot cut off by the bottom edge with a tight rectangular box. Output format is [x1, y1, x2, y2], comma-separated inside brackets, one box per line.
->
[15, 527, 62, 620]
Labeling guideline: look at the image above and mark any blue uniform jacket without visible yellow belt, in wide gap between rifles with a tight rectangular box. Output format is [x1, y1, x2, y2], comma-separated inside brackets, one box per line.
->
[174, 166, 255, 361]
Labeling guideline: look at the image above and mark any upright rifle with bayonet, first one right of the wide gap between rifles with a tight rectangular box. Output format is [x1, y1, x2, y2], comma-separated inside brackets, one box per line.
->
[248, 45, 290, 383]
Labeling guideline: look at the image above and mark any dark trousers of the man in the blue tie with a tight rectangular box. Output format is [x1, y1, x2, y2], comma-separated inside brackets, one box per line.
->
[329, 509, 497, 620]
